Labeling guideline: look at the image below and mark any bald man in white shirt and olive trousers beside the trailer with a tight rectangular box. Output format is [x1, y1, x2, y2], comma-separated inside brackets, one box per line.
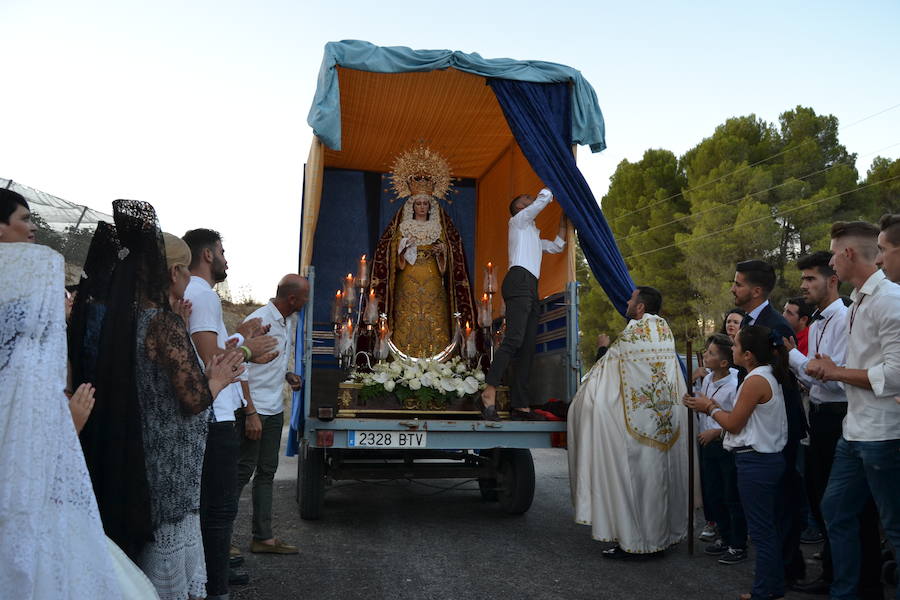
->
[238, 274, 309, 554]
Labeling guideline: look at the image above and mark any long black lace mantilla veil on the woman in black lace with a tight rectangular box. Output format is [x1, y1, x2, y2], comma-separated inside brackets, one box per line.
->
[70, 200, 169, 559]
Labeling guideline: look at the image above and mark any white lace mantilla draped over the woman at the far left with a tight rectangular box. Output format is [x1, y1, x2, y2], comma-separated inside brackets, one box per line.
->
[0, 243, 122, 599]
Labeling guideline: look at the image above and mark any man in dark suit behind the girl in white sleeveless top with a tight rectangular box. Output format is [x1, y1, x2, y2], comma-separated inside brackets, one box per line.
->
[731, 260, 807, 586]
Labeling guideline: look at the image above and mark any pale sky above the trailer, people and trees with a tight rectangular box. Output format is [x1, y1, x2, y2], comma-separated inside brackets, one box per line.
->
[0, 0, 900, 300]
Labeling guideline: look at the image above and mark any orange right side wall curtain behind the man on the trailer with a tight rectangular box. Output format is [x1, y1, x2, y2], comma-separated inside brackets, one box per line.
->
[472, 143, 574, 316]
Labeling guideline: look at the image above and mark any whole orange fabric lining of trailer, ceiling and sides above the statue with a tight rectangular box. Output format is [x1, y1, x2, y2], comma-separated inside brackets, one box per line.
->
[312, 67, 575, 302]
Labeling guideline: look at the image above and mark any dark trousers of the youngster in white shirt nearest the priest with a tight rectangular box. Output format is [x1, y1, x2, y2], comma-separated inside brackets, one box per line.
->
[700, 440, 747, 550]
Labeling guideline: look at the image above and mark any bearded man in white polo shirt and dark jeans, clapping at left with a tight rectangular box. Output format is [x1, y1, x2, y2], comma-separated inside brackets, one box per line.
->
[182, 229, 277, 600]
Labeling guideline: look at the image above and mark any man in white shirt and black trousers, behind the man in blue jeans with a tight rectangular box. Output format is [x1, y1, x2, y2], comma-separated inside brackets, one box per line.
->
[785, 251, 883, 600]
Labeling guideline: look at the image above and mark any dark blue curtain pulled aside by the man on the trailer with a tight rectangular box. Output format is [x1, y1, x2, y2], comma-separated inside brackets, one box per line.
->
[488, 79, 635, 315]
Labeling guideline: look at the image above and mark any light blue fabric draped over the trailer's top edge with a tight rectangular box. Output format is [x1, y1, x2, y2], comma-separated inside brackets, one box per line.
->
[306, 40, 606, 152]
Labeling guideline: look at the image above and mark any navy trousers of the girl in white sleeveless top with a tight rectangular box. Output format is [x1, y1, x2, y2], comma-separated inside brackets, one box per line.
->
[734, 451, 784, 600]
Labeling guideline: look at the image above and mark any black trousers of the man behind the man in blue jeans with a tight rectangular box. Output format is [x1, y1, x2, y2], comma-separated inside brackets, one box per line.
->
[806, 402, 884, 599]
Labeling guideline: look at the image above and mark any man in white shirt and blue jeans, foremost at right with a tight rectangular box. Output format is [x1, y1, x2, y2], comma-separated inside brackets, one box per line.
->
[806, 221, 900, 600]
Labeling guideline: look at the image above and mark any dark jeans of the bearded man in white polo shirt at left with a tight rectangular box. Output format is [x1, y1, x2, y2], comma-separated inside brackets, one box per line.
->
[200, 421, 240, 600]
